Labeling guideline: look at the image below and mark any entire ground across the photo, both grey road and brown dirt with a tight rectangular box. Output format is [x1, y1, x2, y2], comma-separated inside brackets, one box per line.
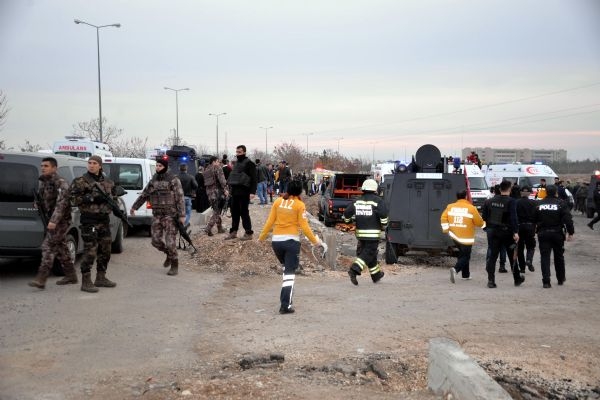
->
[0, 191, 600, 400]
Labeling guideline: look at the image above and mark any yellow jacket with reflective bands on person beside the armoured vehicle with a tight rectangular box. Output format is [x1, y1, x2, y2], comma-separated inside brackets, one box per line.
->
[440, 199, 485, 246]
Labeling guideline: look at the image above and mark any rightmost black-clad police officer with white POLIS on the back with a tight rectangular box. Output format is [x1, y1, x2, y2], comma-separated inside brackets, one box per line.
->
[535, 185, 575, 289]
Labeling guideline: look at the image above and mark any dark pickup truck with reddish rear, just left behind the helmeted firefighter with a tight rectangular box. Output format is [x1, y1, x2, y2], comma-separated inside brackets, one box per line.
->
[318, 173, 371, 226]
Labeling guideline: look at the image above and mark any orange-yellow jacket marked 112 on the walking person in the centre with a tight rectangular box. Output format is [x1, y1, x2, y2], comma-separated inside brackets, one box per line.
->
[258, 196, 319, 244]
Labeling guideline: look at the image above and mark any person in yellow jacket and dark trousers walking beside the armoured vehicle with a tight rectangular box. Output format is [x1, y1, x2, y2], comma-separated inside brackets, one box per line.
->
[440, 190, 485, 283]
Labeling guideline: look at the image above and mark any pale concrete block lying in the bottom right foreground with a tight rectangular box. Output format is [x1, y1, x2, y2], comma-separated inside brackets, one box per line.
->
[427, 338, 512, 400]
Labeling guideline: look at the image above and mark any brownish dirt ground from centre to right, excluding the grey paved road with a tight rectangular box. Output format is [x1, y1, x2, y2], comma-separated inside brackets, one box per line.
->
[83, 192, 600, 399]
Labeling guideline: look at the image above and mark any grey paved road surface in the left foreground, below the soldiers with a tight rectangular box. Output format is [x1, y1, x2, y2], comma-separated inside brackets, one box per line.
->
[0, 234, 220, 400]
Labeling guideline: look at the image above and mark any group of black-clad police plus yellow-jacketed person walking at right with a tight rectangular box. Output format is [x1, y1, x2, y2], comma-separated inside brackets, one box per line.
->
[441, 178, 580, 289]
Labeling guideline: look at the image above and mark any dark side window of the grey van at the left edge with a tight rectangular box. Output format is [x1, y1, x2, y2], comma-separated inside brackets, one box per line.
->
[0, 163, 39, 202]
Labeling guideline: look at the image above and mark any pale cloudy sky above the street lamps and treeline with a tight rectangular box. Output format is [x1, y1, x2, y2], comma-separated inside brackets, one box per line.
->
[0, 0, 600, 160]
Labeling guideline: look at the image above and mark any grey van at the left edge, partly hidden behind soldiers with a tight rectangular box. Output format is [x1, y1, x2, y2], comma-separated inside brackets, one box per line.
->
[0, 151, 126, 275]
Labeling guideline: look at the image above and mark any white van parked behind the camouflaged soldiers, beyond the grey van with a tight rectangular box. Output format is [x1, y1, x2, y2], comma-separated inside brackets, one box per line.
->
[102, 157, 156, 228]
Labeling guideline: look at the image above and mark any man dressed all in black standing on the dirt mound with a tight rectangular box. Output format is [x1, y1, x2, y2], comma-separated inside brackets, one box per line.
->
[225, 144, 257, 240]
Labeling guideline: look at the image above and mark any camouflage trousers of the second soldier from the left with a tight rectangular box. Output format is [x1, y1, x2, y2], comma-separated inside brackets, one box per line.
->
[81, 224, 112, 274]
